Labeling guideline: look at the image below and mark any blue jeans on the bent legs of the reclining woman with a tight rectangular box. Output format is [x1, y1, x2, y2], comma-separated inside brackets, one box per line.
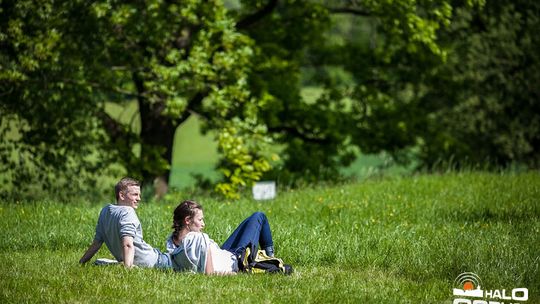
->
[221, 212, 274, 254]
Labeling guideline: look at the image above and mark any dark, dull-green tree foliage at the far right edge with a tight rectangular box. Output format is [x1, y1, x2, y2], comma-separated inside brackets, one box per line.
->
[420, 1, 540, 168]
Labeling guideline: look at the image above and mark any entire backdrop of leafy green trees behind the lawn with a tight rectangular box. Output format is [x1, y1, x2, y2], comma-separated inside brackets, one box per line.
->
[0, 0, 539, 201]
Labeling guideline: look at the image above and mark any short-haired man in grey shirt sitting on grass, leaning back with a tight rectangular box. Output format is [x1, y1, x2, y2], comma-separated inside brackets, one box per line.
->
[79, 177, 172, 268]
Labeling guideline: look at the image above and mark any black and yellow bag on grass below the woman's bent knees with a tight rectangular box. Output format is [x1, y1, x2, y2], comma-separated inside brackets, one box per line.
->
[238, 245, 293, 275]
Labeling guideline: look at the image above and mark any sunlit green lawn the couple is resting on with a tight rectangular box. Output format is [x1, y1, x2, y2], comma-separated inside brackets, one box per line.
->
[0, 172, 540, 303]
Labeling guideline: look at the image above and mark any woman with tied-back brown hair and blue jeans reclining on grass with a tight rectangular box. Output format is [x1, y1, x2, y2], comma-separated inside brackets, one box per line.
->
[167, 201, 274, 274]
